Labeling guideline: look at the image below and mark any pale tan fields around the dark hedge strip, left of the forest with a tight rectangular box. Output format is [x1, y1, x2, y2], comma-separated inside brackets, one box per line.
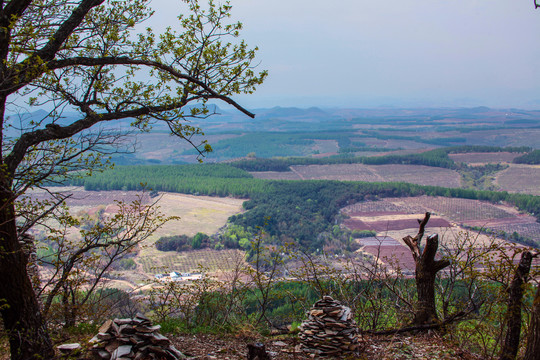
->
[32, 187, 244, 288]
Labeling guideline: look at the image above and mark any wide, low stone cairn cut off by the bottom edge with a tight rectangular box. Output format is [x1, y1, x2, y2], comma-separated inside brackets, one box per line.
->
[90, 314, 186, 360]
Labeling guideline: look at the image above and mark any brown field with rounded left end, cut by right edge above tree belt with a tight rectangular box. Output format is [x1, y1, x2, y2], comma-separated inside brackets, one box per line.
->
[495, 164, 540, 195]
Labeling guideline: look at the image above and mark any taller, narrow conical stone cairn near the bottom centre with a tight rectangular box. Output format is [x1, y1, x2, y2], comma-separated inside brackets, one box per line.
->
[300, 296, 359, 356]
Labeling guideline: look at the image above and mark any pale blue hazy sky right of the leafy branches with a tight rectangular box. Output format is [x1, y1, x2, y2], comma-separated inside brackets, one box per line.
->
[153, 0, 540, 109]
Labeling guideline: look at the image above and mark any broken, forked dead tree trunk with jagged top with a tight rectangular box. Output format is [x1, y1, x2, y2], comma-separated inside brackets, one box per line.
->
[403, 212, 450, 325]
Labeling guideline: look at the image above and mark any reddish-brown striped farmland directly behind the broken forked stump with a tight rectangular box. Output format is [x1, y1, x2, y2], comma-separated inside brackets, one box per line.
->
[342, 196, 540, 270]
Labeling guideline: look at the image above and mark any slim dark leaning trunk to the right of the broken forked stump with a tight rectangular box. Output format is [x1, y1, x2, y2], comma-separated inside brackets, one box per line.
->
[499, 251, 532, 360]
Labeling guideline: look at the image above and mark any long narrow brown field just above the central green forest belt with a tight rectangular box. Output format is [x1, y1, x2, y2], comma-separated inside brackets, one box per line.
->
[252, 164, 460, 187]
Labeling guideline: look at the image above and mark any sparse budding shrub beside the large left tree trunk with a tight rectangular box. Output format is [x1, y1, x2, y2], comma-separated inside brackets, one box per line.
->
[38, 198, 173, 327]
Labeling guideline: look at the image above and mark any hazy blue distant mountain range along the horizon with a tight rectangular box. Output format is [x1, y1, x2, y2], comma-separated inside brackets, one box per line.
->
[8, 104, 540, 136]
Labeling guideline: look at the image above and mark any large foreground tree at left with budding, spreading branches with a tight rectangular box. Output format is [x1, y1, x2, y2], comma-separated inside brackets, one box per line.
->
[0, 0, 266, 359]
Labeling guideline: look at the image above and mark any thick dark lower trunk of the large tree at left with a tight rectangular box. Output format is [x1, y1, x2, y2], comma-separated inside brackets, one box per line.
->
[0, 188, 54, 360]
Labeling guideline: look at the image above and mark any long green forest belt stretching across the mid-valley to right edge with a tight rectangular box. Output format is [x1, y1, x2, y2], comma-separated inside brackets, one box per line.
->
[61, 164, 540, 251]
